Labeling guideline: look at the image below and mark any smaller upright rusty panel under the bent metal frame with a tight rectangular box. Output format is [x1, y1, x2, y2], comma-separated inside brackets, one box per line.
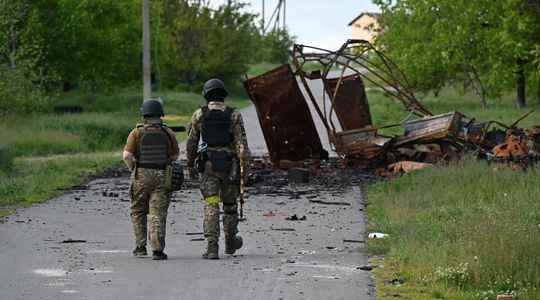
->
[324, 74, 373, 130]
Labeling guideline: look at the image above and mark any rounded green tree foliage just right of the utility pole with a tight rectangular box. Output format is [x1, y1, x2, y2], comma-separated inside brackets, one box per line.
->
[160, 1, 258, 91]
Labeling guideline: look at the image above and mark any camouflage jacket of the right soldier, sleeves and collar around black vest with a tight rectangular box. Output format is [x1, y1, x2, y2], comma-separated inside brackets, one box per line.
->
[186, 102, 251, 167]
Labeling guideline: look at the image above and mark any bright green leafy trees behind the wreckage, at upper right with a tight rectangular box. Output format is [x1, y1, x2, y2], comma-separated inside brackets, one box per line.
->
[373, 0, 540, 106]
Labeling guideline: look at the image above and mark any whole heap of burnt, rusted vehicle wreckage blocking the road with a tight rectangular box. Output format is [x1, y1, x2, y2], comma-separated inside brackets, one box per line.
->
[244, 40, 540, 176]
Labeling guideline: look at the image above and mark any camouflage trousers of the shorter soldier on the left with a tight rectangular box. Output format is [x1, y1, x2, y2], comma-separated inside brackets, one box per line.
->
[130, 168, 171, 251]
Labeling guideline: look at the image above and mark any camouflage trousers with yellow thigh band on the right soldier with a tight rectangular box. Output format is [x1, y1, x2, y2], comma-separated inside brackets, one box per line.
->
[201, 173, 240, 242]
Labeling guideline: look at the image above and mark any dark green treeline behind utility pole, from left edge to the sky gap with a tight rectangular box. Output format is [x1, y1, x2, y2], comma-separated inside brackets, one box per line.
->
[0, 0, 293, 115]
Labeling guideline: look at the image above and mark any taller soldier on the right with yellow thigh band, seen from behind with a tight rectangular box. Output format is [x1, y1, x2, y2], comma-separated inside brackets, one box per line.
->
[186, 79, 249, 259]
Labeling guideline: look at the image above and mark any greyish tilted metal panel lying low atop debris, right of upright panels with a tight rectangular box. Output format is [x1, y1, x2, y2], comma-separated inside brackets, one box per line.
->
[396, 112, 462, 146]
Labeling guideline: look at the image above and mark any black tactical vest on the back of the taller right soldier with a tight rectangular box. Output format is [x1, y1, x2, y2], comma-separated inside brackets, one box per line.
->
[201, 106, 234, 147]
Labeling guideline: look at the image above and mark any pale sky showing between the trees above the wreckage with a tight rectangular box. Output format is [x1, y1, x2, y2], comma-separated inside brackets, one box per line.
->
[210, 0, 378, 50]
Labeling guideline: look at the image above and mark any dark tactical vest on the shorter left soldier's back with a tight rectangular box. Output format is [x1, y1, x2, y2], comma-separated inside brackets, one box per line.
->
[137, 124, 170, 169]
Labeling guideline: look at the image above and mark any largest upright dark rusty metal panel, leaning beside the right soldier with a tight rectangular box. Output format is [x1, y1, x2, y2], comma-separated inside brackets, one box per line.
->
[244, 65, 328, 165]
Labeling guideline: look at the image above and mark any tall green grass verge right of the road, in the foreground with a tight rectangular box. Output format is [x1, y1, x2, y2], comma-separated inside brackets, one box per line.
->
[368, 159, 540, 300]
